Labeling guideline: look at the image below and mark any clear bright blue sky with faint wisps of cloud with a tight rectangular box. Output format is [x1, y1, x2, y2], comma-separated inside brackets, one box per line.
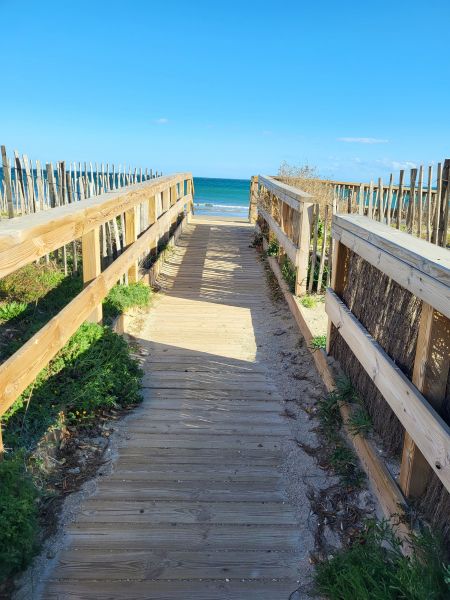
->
[0, 0, 450, 180]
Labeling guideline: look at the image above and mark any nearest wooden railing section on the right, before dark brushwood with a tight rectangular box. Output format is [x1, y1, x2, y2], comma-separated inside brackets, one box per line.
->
[326, 215, 450, 496]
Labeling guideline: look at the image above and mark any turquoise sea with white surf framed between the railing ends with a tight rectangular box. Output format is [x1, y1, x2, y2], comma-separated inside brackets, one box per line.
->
[194, 177, 250, 219]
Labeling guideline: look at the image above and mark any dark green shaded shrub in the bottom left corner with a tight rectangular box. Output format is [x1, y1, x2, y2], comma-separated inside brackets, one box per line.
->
[0, 454, 38, 582]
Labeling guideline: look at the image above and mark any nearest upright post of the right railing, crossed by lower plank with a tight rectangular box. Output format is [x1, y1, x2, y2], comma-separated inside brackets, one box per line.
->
[399, 302, 450, 497]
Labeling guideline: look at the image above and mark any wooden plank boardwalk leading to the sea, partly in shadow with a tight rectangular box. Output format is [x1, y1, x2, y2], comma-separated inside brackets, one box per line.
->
[43, 218, 305, 600]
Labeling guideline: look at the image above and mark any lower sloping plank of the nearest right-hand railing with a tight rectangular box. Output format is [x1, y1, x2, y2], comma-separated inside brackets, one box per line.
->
[325, 290, 450, 489]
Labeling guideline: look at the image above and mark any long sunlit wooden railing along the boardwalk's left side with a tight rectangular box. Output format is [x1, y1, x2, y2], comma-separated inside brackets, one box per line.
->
[0, 173, 193, 451]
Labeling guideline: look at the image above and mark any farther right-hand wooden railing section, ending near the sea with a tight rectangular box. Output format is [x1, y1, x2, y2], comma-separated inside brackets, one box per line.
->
[249, 175, 314, 295]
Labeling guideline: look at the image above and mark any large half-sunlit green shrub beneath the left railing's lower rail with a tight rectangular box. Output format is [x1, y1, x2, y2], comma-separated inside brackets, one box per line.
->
[3, 323, 141, 449]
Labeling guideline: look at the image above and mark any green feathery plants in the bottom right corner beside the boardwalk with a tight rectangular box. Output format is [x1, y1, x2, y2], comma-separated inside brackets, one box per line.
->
[315, 520, 450, 600]
